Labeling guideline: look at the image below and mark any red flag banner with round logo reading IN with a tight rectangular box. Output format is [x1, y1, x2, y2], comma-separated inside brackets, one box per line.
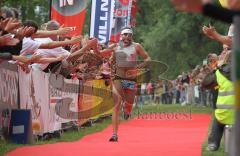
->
[51, 0, 88, 36]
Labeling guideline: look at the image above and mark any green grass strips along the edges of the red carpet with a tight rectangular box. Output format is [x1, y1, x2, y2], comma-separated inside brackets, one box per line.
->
[0, 104, 225, 156]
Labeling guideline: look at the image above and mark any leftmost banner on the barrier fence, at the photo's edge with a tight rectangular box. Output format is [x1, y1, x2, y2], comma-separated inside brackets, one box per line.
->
[0, 62, 19, 109]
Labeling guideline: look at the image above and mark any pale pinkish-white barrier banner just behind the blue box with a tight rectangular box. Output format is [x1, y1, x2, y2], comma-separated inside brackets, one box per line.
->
[19, 69, 50, 135]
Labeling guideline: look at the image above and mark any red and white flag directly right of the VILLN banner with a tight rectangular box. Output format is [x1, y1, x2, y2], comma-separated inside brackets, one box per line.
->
[111, 0, 132, 42]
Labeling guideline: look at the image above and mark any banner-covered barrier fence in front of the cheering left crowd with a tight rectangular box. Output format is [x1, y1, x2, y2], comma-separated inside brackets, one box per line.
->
[0, 62, 113, 135]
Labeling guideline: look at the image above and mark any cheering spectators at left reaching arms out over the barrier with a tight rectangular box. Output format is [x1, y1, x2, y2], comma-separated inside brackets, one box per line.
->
[0, 7, 120, 79]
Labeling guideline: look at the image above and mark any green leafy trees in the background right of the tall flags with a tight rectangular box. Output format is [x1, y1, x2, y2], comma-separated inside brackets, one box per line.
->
[135, 0, 227, 79]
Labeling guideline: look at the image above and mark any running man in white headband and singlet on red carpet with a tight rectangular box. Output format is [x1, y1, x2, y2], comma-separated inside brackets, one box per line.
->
[109, 27, 151, 142]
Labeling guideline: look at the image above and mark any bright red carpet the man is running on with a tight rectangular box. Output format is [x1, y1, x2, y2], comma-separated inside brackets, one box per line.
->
[8, 115, 211, 156]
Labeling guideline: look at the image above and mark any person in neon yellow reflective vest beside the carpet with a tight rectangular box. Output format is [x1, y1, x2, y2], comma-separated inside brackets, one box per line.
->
[202, 56, 235, 151]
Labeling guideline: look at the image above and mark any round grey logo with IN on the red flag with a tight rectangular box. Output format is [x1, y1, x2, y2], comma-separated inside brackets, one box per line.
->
[52, 0, 88, 16]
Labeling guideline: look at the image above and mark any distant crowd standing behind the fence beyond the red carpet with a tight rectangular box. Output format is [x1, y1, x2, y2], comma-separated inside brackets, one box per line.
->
[136, 80, 214, 108]
